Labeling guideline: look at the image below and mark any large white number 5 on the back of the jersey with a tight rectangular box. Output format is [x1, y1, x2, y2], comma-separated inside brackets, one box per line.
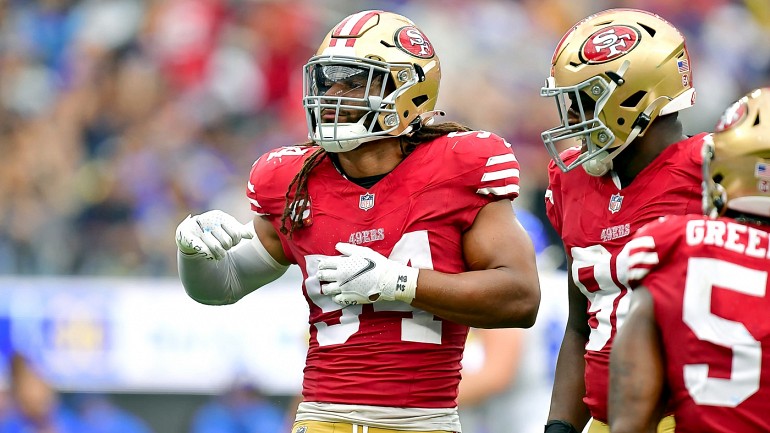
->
[682, 257, 767, 407]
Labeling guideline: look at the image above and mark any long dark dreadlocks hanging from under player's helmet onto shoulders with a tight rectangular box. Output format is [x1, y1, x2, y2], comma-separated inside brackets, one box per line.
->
[280, 122, 471, 239]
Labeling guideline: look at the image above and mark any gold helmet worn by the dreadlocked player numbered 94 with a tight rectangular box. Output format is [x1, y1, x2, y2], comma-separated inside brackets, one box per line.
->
[303, 10, 441, 152]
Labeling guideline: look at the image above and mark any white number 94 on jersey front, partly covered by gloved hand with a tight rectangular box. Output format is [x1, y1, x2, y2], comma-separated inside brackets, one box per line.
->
[305, 230, 441, 346]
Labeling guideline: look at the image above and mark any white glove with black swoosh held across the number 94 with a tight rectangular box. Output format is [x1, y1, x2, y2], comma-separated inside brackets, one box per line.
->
[318, 243, 420, 305]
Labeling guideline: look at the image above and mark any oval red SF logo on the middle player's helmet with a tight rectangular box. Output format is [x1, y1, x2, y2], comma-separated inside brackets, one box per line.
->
[580, 26, 642, 64]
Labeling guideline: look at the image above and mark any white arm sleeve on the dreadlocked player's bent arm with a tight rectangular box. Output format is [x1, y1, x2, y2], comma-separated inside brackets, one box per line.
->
[177, 236, 289, 305]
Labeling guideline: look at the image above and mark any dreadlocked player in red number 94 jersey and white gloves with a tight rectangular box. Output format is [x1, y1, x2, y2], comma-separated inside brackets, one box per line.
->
[172, 11, 540, 433]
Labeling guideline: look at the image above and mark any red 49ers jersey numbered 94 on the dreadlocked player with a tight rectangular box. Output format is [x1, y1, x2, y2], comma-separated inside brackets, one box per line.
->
[247, 131, 519, 408]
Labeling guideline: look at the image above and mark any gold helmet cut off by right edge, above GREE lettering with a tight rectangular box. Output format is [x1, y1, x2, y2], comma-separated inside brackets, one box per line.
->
[703, 87, 770, 218]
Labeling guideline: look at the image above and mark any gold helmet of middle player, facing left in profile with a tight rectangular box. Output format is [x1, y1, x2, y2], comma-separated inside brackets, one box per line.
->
[540, 9, 695, 176]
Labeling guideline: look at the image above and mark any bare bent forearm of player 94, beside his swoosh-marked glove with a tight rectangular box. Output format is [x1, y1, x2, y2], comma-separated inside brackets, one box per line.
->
[412, 268, 540, 328]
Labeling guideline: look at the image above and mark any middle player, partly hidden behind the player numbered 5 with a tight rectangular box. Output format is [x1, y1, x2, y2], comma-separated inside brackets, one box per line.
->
[541, 9, 706, 433]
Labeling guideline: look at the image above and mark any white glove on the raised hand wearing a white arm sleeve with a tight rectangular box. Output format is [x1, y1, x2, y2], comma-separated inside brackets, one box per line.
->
[176, 210, 256, 260]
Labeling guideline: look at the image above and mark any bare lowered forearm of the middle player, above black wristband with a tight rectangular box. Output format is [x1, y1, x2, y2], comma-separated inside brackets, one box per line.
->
[548, 326, 591, 431]
